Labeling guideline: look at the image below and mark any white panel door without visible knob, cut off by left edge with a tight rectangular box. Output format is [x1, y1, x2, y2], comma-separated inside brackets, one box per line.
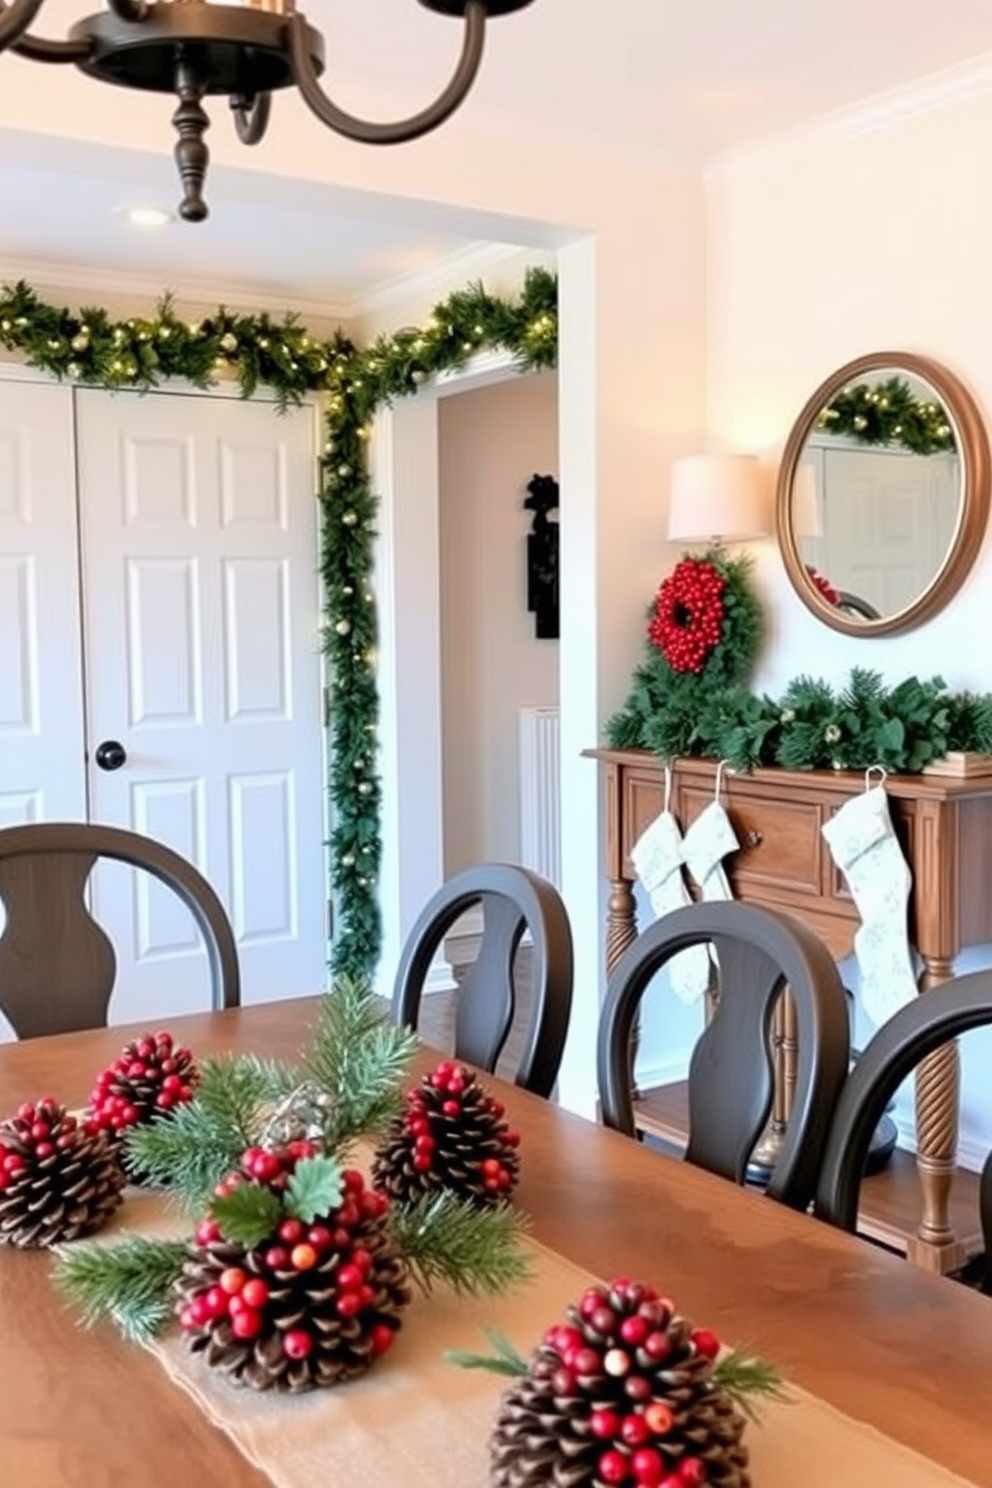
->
[0, 379, 86, 827]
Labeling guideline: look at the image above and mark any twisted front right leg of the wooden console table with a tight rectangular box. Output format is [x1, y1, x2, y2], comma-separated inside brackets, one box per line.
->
[907, 957, 967, 1274]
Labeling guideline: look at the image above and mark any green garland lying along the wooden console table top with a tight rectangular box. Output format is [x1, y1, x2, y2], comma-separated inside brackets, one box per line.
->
[607, 668, 992, 774]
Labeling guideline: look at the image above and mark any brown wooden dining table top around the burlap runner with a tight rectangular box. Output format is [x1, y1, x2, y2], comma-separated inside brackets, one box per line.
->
[0, 1000, 992, 1488]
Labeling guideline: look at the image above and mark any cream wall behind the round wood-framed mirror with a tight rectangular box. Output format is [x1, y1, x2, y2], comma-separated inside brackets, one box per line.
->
[708, 94, 992, 1162]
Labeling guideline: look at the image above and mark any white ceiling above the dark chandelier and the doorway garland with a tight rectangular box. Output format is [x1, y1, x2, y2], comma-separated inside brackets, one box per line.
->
[0, 0, 992, 308]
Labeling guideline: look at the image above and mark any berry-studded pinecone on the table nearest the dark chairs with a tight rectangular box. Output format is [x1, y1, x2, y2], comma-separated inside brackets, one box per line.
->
[372, 1059, 521, 1204]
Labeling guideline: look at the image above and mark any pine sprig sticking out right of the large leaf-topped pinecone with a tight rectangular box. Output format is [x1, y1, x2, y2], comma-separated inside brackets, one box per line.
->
[390, 1193, 532, 1295]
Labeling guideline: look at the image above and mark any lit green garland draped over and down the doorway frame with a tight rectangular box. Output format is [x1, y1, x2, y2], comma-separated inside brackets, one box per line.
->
[0, 268, 558, 975]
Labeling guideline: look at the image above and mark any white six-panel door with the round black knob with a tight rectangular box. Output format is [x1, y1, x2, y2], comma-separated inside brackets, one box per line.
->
[77, 390, 327, 1019]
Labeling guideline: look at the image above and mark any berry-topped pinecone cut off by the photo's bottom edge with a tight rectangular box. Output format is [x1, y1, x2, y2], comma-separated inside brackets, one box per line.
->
[491, 1280, 751, 1488]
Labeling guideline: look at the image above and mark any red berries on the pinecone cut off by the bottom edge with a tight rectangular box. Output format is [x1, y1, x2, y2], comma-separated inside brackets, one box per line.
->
[544, 1277, 720, 1488]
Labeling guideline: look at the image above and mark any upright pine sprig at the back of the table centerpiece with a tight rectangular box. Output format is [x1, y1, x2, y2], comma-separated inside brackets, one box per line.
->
[303, 975, 416, 1147]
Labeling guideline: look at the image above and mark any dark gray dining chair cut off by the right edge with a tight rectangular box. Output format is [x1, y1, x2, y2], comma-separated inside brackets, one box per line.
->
[815, 972, 992, 1290]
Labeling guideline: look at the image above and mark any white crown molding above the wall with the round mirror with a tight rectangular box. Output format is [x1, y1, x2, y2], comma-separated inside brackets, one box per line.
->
[703, 52, 992, 189]
